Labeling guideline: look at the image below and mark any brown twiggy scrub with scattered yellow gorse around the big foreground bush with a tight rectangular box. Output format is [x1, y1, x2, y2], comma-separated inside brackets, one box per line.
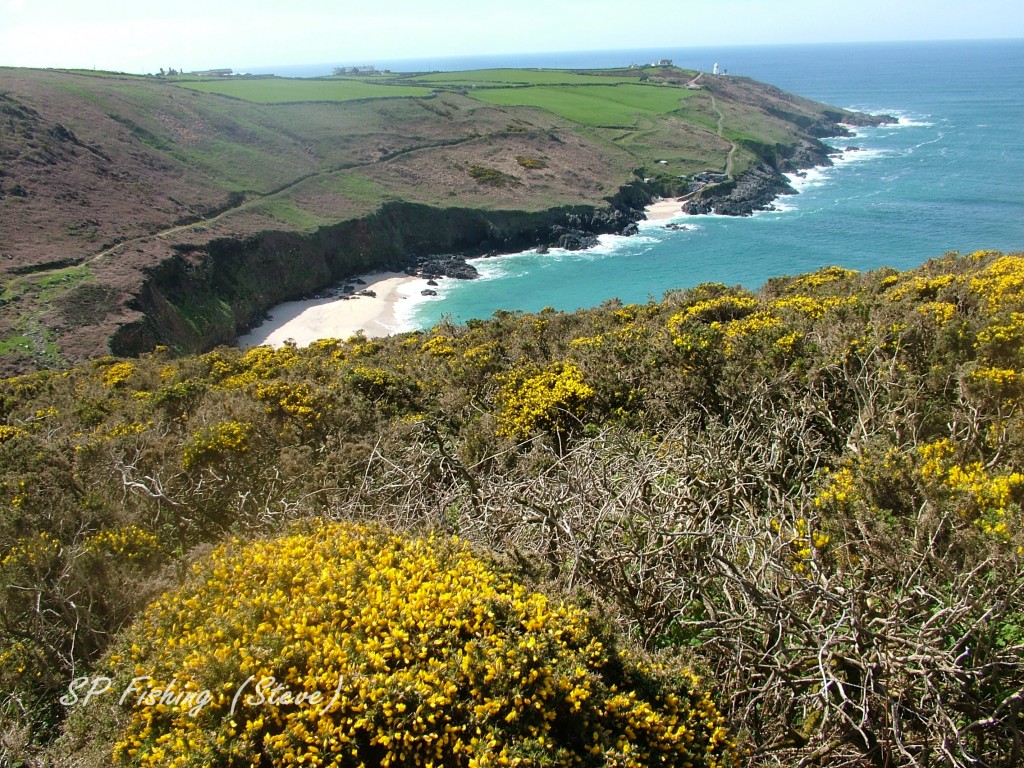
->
[6, 253, 1024, 768]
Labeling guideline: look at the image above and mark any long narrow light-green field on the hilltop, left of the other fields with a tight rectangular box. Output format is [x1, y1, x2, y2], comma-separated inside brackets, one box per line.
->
[180, 78, 429, 104]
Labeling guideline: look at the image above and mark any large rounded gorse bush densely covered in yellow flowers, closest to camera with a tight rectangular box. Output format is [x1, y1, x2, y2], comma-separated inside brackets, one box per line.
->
[96, 524, 733, 768]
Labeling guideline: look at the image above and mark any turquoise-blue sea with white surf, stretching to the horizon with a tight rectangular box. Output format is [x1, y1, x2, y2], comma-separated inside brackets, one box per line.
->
[266, 40, 1024, 327]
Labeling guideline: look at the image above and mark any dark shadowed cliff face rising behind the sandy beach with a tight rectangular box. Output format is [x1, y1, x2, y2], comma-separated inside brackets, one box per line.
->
[110, 193, 651, 356]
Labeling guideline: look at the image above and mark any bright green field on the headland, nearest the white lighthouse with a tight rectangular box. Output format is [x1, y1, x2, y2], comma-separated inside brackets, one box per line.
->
[472, 84, 695, 126]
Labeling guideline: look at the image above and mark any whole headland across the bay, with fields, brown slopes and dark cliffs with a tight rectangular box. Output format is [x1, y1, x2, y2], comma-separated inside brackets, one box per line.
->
[0, 67, 897, 373]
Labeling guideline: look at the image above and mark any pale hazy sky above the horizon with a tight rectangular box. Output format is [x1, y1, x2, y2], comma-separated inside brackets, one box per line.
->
[0, 0, 1024, 73]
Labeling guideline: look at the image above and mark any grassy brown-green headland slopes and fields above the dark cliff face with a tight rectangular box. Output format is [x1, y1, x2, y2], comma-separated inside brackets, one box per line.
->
[0, 68, 872, 372]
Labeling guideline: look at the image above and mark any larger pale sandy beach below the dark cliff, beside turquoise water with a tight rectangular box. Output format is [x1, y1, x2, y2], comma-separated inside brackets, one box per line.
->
[239, 272, 426, 349]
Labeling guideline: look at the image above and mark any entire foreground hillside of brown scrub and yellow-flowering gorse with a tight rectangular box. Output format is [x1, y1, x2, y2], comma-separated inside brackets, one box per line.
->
[0, 253, 1024, 767]
